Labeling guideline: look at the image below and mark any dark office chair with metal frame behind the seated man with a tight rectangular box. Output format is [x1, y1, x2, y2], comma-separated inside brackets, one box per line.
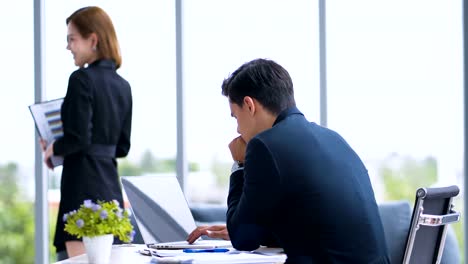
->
[403, 185, 460, 264]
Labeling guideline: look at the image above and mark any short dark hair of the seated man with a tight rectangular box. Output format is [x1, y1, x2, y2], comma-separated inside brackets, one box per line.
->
[221, 59, 296, 115]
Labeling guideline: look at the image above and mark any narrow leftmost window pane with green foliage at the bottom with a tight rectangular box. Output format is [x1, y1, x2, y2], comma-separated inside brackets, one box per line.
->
[0, 1, 35, 263]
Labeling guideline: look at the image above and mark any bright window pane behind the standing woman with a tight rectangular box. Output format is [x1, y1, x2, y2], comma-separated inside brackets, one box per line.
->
[45, 0, 177, 258]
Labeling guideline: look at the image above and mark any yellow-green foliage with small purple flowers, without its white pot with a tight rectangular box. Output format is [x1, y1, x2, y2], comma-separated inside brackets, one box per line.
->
[63, 200, 135, 242]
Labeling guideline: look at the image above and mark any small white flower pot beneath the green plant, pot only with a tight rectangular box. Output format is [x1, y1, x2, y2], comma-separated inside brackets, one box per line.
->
[83, 234, 114, 264]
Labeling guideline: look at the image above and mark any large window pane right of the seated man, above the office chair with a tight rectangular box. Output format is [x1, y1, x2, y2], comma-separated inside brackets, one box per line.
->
[327, 0, 463, 260]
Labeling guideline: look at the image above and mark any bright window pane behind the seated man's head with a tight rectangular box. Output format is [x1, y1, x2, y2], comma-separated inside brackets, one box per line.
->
[183, 0, 319, 203]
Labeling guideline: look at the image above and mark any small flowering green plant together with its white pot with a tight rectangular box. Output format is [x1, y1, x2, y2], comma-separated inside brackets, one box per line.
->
[63, 200, 135, 263]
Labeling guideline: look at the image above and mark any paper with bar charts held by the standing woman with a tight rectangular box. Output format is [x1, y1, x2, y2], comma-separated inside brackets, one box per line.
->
[29, 98, 63, 167]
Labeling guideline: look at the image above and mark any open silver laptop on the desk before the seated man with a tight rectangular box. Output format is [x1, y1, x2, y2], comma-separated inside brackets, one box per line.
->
[121, 174, 232, 249]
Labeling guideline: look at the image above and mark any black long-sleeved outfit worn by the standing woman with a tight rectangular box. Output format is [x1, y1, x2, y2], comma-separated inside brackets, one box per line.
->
[54, 60, 132, 251]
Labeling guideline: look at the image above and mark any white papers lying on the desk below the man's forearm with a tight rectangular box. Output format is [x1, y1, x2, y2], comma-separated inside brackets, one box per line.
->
[151, 247, 286, 264]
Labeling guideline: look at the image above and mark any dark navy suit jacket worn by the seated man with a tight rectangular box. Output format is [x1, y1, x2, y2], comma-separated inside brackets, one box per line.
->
[227, 107, 389, 264]
